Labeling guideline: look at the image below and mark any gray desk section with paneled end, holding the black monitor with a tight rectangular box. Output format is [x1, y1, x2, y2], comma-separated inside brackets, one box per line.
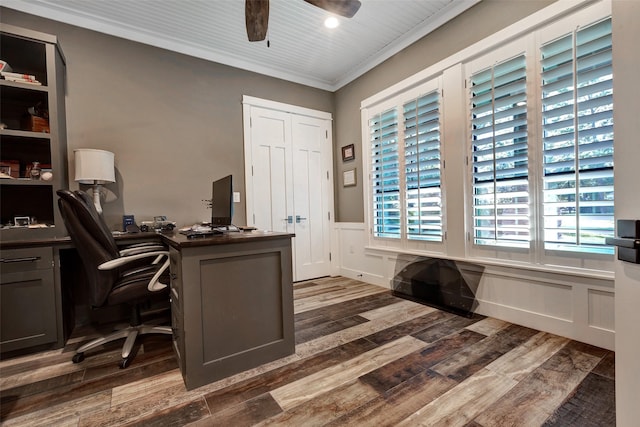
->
[161, 231, 295, 390]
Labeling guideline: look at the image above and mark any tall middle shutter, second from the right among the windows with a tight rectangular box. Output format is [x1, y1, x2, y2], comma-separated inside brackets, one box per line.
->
[469, 54, 530, 248]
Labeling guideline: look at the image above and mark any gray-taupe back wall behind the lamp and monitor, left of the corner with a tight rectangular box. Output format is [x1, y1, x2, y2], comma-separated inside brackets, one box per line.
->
[0, 8, 333, 228]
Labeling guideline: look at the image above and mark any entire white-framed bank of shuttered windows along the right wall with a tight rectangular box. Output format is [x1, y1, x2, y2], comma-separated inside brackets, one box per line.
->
[361, 0, 614, 272]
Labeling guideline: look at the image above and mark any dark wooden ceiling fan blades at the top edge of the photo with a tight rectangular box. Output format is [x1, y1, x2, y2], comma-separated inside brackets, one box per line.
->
[244, 0, 361, 42]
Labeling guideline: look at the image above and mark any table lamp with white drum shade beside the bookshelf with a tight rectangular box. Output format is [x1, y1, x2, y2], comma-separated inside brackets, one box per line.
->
[73, 148, 116, 214]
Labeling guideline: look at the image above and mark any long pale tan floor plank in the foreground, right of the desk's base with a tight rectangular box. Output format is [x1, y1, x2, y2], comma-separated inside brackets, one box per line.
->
[271, 337, 424, 410]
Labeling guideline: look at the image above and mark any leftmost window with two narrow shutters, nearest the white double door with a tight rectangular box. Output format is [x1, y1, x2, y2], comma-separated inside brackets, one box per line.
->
[368, 87, 443, 245]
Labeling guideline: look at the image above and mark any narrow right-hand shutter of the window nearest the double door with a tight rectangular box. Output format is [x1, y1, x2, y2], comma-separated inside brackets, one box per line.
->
[403, 90, 442, 242]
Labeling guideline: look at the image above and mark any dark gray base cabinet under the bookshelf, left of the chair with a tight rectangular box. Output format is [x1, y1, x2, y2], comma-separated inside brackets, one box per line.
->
[0, 247, 59, 353]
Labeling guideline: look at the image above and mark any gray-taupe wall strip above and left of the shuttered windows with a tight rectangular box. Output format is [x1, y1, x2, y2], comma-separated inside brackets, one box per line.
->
[334, 0, 553, 222]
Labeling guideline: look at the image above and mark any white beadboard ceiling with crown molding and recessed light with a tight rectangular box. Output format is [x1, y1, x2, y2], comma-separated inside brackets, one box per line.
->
[0, 0, 480, 91]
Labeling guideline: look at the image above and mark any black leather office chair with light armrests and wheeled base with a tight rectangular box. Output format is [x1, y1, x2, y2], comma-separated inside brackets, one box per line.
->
[57, 190, 171, 368]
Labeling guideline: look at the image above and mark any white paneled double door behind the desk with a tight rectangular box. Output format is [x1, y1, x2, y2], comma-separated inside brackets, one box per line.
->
[243, 97, 333, 281]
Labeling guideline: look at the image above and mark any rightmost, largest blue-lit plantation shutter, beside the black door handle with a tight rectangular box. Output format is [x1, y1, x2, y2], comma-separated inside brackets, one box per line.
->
[541, 19, 614, 253]
